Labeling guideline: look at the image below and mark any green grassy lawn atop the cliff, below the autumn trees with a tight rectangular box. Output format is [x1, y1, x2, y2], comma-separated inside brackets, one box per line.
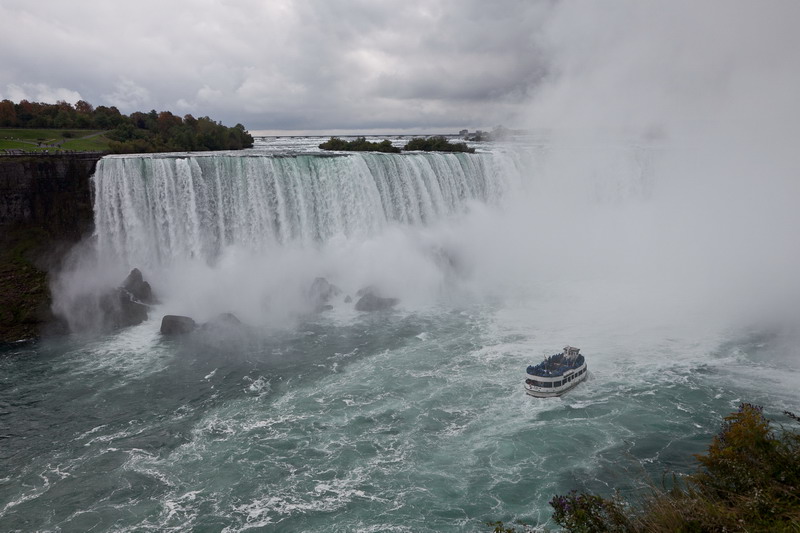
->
[0, 128, 109, 153]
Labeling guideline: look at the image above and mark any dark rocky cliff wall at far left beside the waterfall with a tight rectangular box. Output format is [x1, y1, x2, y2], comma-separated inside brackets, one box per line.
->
[0, 153, 102, 344]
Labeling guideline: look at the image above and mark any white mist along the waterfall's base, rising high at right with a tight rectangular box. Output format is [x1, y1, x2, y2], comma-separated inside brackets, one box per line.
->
[48, 2, 800, 350]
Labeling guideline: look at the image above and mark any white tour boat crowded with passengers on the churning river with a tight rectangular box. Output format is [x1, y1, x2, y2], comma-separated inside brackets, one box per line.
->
[525, 346, 586, 398]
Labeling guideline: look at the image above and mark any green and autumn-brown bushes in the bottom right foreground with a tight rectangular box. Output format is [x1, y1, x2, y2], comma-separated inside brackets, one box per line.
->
[489, 403, 800, 533]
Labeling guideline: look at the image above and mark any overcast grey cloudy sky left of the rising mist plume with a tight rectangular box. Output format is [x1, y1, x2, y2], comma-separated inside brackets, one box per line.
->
[0, 0, 551, 131]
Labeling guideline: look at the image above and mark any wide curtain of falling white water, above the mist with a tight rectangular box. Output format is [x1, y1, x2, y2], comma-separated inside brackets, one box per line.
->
[94, 153, 520, 266]
